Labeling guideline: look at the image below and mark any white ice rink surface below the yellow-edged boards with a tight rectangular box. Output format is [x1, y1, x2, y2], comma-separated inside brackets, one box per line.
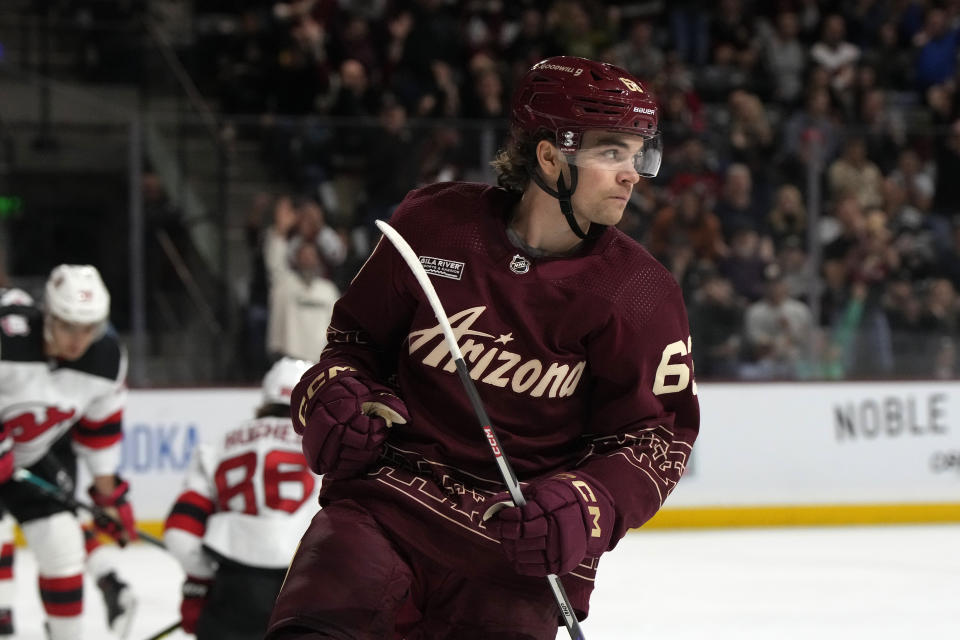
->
[14, 525, 960, 640]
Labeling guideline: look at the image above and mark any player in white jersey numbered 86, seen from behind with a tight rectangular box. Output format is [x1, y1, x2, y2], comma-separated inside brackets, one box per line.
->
[164, 358, 320, 640]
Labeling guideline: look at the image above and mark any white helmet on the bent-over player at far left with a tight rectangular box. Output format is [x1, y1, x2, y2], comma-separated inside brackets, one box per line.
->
[44, 264, 110, 324]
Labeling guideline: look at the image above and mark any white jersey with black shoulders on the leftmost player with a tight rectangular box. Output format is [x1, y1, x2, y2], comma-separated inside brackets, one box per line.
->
[0, 292, 127, 475]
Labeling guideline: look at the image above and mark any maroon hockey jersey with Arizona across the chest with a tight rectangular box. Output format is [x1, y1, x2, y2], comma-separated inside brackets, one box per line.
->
[301, 183, 699, 615]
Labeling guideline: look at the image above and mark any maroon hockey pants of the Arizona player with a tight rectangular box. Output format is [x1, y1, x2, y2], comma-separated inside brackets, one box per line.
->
[265, 501, 557, 640]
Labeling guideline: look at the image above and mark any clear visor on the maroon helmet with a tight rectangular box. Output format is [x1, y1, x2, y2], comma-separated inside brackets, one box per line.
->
[563, 131, 663, 178]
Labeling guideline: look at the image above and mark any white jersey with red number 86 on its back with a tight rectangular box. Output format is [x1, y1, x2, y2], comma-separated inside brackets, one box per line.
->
[165, 417, 320, 578]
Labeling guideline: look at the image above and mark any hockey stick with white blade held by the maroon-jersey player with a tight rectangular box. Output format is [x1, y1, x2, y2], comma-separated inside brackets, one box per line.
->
[376, 220, 586, 640]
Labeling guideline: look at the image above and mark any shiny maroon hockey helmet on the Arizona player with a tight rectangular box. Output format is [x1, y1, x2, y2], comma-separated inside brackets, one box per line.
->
[511, 56, 661, 177]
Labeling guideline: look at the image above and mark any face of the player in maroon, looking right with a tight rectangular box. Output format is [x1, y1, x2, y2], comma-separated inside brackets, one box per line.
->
[572, 130, 645, 226]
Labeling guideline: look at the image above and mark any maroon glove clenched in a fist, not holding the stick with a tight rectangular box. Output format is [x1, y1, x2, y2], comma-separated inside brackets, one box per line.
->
[290, 371, 410, 478]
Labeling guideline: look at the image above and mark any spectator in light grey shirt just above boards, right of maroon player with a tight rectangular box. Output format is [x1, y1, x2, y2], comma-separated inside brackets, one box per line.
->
[740, 265, 814, 380]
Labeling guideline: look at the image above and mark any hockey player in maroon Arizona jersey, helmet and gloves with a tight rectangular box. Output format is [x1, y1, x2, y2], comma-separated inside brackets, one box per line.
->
[267, 57, 700, 640]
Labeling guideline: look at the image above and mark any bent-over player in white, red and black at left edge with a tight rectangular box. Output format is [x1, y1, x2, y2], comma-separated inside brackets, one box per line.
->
[0, 265, 136, 640]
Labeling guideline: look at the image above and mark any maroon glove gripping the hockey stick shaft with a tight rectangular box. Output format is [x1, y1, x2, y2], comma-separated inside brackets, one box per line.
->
[484, 473, 615, 577]
